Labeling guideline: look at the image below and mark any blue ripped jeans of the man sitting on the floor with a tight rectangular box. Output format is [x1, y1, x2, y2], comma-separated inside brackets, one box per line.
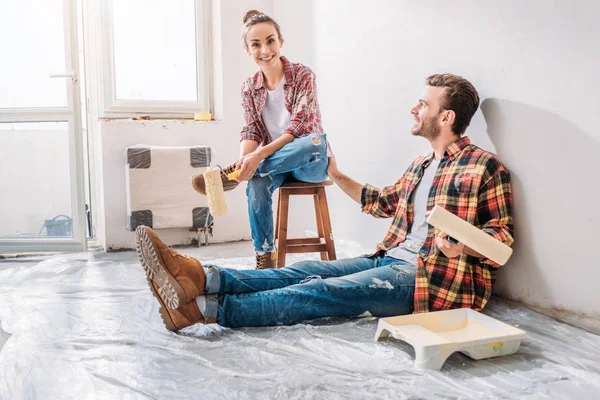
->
[205, 256, 416, 328]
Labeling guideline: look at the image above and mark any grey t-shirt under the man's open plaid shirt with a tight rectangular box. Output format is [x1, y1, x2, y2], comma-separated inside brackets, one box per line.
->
[386, 160, 440, 265]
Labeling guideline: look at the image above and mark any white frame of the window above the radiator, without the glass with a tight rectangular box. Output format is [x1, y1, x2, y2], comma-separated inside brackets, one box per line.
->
[96, 0, 214, 118]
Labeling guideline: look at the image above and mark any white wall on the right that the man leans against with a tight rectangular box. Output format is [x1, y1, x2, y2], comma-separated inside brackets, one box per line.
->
[275, 0, 600, 318]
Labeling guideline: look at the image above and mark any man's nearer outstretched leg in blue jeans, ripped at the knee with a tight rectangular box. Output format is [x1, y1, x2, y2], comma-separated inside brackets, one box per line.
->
[207, 261, 415, 328]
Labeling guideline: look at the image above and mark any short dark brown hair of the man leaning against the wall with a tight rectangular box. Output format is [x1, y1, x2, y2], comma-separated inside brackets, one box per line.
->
[425, 74, 479, 135]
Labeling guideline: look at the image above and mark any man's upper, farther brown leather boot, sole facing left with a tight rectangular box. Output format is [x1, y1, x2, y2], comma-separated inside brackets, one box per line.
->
[135, 226, 206, 309]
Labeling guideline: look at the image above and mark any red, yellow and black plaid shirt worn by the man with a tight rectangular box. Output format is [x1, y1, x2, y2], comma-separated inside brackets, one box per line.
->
[361, 137, 514, 313]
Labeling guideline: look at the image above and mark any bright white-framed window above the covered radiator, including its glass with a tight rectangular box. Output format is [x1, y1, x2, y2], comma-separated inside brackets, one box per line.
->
[98, 0, 211, 117]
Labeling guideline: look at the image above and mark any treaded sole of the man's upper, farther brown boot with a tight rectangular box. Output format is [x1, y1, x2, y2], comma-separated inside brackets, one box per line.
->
[135, 226, 187, 310]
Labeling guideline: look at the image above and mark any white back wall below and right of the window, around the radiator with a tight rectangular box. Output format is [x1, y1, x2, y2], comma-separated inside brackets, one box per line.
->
[95, 0, 273, 250]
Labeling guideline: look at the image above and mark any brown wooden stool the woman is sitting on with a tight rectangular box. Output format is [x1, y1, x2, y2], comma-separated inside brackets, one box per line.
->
[275, 181, 336, 268]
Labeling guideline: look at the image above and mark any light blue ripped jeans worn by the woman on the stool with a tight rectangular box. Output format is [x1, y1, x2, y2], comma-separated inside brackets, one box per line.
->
[246, 133, 329, 253]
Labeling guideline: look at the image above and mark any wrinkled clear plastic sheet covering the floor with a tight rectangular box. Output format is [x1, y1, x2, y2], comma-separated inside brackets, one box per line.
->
[0, 248, 600, 399]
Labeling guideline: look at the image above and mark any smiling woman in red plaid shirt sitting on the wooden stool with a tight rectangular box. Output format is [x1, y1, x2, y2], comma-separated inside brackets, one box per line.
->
[192, 10, 328, 269]
